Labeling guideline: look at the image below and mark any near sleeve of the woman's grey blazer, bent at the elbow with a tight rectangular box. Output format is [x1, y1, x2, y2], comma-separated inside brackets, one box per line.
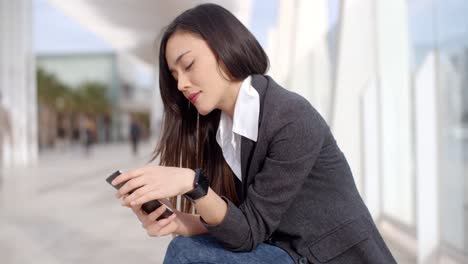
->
[202, 104, 328, 251]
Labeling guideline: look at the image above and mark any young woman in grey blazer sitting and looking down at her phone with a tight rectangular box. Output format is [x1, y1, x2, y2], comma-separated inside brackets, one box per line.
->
[113, 4, 395, 264]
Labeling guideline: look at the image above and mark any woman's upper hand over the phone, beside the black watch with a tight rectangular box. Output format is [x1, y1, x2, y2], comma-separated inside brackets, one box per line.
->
[112, 166, 195, 206]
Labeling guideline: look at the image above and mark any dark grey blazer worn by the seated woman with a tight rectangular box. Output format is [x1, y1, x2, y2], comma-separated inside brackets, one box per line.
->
[202, 75, 396, 264]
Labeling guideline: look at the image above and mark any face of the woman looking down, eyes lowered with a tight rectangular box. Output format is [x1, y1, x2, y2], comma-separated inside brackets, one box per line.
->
[166, 32, 230, 115]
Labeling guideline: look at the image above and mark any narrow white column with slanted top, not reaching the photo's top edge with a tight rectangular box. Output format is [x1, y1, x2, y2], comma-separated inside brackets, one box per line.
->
[415, 53, 440, 264]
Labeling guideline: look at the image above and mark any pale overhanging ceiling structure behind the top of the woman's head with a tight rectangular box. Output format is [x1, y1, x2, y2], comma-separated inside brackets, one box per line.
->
[48, 0, 253, 66]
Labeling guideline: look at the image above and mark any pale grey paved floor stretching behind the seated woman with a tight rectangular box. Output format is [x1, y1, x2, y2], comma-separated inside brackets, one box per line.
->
[0, 143, 415, 264]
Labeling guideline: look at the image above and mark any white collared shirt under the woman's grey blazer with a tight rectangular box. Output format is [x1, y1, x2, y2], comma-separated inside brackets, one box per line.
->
[216, 76, 260, 181]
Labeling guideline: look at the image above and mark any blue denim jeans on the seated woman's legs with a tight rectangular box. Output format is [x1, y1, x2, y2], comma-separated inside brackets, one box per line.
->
[164, 235, 294, 264]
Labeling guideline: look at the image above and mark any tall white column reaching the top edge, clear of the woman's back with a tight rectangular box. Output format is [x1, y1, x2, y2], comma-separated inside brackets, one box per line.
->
[376, 0, 415, 226]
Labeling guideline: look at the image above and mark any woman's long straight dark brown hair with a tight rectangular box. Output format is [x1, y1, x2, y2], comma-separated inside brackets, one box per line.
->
[152, 4, 269, 212]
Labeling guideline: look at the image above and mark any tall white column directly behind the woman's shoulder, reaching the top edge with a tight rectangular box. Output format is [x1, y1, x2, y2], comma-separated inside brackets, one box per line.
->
[331, 0, 375, 194]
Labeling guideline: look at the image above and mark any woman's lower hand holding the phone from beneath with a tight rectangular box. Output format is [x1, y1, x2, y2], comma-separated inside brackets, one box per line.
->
[131, 200, 180, 237]
